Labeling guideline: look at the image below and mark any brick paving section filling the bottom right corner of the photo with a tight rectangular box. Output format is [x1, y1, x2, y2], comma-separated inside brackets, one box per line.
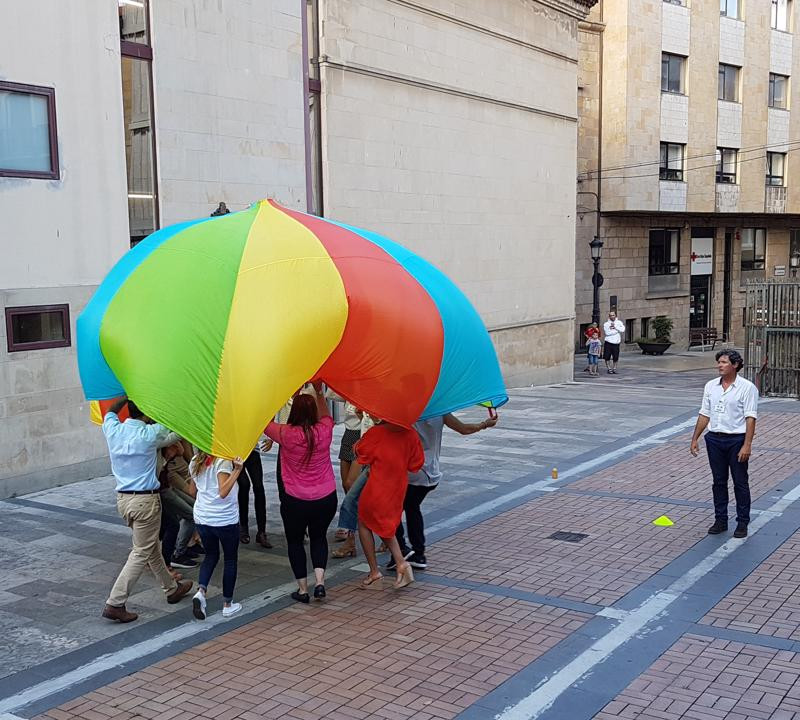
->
[595, 635, 800, 720]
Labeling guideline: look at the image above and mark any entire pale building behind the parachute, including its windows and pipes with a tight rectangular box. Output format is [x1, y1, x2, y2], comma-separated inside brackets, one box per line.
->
[0, 0, 596, 497]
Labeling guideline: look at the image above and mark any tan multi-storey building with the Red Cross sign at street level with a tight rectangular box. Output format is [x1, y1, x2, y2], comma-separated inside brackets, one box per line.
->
[575, 0, 800, 349]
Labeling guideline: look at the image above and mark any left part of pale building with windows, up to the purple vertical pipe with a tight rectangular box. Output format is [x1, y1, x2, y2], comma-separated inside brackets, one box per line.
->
[0, 0, 306, 498]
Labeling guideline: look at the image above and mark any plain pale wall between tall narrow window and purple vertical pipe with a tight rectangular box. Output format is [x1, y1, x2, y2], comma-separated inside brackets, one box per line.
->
[151, 0, 306, 225]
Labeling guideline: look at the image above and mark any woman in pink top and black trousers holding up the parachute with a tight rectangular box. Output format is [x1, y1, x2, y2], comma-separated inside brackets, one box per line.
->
[264, 385, 337, 603]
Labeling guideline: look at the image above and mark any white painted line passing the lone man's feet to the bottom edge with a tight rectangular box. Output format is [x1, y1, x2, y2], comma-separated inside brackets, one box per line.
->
[495, 476, 800, 720]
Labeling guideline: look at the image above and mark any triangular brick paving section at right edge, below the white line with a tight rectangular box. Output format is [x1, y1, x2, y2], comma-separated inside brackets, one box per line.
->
[701, 532, 800, 640]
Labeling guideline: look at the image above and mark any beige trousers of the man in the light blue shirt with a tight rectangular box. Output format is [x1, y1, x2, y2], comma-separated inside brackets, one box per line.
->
[106, 493, 178, 607]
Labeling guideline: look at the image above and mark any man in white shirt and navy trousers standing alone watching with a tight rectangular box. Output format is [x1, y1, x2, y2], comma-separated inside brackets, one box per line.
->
[689, 350, 758, 538]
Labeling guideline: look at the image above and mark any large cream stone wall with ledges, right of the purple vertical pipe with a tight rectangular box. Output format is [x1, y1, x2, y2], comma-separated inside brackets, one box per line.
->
[320, 0, 583, 385]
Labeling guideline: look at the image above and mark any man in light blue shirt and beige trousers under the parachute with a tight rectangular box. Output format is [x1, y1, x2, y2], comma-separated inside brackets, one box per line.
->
[103, 397, 192, 623]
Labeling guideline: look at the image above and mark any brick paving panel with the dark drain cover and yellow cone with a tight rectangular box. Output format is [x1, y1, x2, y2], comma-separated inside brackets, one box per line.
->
[428, 493, 708, 605]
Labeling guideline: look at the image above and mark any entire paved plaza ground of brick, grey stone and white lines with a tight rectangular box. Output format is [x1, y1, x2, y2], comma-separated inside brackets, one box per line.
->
[0, 354, 800, 720]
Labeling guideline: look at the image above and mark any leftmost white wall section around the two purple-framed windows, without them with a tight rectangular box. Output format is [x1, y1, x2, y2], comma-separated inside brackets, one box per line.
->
[0, 0, 128, 497]
